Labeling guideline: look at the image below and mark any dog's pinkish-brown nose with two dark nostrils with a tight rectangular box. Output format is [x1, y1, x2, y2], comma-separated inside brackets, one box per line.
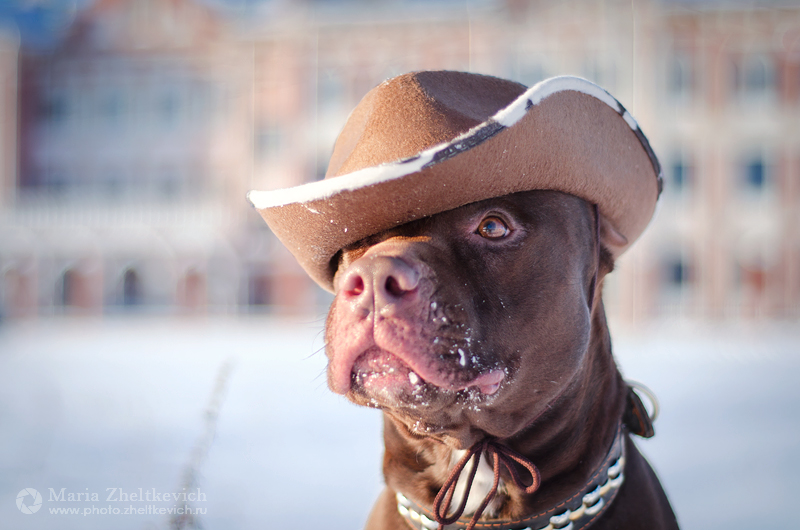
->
[339, 256, 420, 312]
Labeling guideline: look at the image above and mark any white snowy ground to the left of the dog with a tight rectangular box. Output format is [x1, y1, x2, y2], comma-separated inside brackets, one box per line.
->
[0, 318, 382, 530]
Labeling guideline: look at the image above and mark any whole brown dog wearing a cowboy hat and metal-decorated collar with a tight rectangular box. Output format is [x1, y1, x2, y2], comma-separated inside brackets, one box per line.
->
[249, 72, 677, 530]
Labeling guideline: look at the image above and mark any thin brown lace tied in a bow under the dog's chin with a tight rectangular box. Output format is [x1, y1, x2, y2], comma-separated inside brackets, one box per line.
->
[433, 438, 541, 530]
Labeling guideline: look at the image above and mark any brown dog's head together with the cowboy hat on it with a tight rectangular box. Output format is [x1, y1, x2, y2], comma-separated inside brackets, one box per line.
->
[250, 72, 661, 447]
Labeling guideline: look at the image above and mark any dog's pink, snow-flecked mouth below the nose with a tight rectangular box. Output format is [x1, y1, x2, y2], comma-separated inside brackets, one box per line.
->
[350, 346, 505, 404]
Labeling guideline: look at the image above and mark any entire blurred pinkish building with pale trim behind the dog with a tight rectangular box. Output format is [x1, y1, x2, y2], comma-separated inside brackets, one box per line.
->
[0, 0, 800, 321]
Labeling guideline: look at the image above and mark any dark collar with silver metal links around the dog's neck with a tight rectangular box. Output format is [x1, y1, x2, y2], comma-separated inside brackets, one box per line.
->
[397, 426, 625, 530]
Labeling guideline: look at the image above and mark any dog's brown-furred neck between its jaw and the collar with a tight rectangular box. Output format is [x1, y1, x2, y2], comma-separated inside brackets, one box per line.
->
[384, 293, 627, 518]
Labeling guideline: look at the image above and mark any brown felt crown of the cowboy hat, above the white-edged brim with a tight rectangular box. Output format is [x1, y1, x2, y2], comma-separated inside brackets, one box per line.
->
[325, 71, 526, 178]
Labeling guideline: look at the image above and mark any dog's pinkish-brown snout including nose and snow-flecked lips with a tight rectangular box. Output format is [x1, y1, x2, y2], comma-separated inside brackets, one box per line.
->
[326, 241, 505, 400]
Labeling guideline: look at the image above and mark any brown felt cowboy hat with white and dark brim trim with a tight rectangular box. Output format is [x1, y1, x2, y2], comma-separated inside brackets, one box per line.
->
[248, 71, 661, 291]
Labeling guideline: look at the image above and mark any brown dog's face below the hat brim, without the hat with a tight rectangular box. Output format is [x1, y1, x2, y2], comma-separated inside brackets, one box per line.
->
[326, 191, 608, 446]
